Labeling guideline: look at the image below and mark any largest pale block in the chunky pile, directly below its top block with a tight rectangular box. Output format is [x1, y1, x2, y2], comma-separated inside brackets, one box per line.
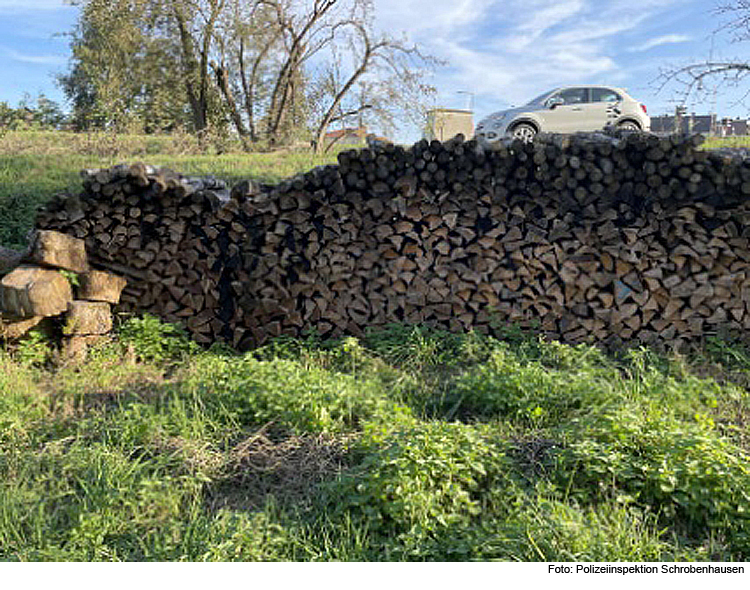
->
[0, 266, 73, 318]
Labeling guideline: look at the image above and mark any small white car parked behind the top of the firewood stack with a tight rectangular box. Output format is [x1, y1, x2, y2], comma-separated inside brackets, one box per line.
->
[476, 86, 651, 144]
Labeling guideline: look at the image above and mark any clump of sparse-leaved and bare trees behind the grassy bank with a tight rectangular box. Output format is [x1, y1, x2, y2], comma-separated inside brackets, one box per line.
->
[63, 0, 444, 149]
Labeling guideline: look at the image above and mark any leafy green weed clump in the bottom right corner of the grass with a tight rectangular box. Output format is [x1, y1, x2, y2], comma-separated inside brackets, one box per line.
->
[557, 412, 750, 557]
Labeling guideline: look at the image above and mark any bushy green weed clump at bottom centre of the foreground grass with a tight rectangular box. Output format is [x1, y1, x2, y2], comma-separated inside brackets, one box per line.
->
[318, 422, 514, 559]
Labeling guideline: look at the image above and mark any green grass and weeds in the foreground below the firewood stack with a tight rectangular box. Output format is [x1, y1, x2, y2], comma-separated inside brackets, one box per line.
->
[0, 318, 750, 561]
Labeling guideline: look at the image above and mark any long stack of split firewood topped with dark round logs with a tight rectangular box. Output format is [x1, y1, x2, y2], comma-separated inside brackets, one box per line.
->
[38, 133, 750, 348]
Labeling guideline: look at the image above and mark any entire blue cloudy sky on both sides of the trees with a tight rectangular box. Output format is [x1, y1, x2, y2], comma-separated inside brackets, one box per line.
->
[0, 0, 750, 138]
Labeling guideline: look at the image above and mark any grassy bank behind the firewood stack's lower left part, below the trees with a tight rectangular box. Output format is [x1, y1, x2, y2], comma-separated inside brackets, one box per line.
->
[0, 131, 336, 248]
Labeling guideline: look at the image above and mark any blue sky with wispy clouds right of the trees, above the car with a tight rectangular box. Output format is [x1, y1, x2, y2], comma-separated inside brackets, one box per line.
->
[376, 0, 750, 119]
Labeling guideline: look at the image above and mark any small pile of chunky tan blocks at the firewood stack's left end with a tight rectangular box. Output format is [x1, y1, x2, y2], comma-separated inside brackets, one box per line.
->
[0, 230, 126, 357]
